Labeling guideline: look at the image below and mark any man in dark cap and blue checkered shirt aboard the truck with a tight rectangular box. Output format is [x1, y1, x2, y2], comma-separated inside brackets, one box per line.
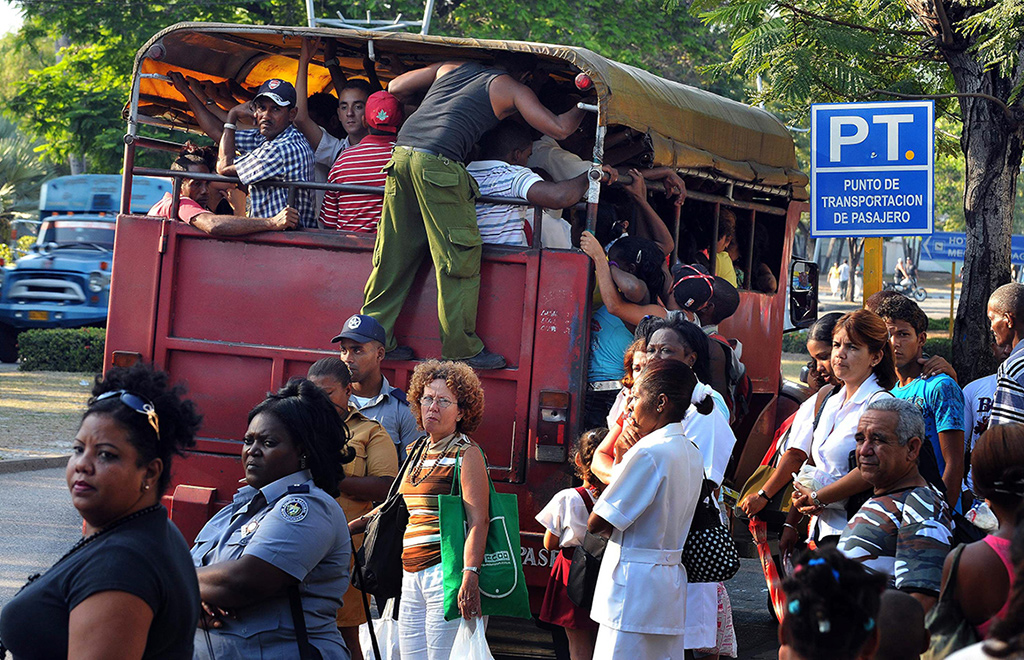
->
[217, 78, 316, 227]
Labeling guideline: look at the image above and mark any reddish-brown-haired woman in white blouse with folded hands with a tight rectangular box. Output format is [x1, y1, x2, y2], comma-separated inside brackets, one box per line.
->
[791, 309, 896, 544]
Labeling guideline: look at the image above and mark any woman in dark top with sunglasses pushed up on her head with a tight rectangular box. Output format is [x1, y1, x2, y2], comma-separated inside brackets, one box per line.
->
[0, 365, 201, 659]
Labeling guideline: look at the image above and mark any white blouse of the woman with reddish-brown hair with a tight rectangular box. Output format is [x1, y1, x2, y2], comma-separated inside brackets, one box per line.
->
[810, 373, 892, 539]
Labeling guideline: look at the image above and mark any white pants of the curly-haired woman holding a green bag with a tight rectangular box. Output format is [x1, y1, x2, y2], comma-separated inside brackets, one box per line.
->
[398, 564, 461, 660]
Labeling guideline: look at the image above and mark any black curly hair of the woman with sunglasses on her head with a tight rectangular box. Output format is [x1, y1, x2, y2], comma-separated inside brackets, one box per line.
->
[82, 363, 203, 495]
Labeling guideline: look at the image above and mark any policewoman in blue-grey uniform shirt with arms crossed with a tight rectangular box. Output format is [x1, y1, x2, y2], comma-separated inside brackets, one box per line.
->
[191, 379, 351, 660]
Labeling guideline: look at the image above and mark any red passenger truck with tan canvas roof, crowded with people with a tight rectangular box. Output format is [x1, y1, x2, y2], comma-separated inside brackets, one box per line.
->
[105, 24, 817, 601]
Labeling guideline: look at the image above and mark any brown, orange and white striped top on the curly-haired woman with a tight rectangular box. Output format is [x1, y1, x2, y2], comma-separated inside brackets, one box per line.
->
[398, 433, 475, 573]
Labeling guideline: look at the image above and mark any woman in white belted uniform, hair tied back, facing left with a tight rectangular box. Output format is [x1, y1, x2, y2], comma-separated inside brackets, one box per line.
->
[588, 360, 714, 659]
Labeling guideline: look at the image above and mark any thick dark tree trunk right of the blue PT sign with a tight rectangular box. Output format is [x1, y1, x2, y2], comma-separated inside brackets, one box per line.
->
[945, 50, 1024, 384]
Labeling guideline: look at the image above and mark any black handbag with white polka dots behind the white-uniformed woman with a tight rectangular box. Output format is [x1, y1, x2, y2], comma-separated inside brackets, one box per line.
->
[683, 472, 739, 583]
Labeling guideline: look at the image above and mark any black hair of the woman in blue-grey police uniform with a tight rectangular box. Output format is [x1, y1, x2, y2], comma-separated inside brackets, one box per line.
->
[249, 378, 355, 497]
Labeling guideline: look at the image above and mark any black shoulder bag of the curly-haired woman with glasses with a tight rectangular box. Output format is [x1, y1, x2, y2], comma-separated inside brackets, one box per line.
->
[352, 441, 427, 603]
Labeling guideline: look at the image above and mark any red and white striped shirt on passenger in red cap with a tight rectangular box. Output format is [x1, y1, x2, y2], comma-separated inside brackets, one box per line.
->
[321, 135, 394, 232]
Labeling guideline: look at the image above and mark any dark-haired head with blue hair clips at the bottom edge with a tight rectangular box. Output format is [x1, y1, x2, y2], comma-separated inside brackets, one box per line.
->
[778, 549, 887, 660]
